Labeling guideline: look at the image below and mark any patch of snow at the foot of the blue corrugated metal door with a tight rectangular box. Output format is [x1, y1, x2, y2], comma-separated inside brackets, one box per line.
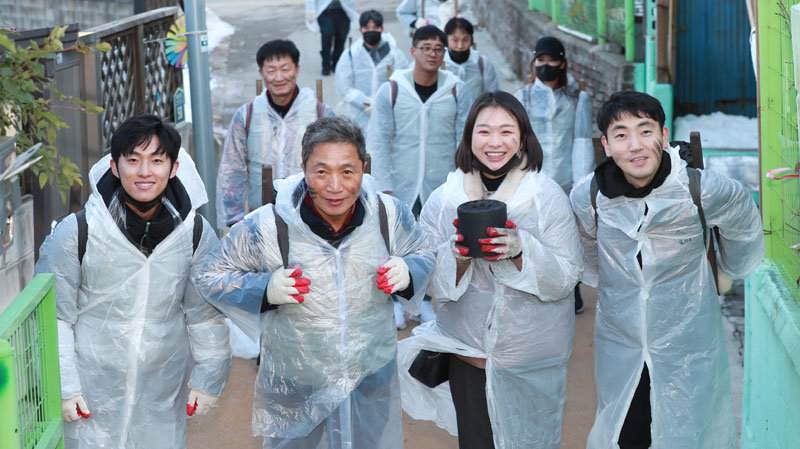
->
[671, 112, 758, 150]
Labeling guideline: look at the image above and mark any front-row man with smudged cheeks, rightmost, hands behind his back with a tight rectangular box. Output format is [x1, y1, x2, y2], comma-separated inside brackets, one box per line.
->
[570, 91, 764, 449]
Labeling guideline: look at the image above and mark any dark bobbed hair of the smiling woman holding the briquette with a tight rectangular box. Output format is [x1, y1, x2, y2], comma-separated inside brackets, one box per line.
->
[456, 90, 543, 173]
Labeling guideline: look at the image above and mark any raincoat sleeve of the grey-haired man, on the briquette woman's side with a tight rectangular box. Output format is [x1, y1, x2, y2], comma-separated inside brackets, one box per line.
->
[381, 194, 436, 305]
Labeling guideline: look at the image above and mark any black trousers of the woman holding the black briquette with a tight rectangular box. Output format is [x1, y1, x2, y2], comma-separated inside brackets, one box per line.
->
[450, 354, 494, 449]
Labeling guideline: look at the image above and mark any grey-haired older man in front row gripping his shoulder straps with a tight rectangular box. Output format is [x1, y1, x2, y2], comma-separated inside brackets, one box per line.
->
[195, 117, 435, 449]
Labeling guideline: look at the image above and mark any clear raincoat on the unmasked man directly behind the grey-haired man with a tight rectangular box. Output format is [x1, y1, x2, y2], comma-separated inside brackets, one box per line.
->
[217, 88, 333, 229]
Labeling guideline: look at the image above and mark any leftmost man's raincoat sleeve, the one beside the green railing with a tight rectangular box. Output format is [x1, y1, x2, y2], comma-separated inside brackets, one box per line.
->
[35, 214, 82, 399]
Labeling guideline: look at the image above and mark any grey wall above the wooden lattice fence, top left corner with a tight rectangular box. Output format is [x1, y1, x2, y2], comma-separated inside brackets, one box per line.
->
[0, 0, 133, 30]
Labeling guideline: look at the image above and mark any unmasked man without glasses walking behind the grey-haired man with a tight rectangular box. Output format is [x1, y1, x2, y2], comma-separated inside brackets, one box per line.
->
[217, 39, 333, 229]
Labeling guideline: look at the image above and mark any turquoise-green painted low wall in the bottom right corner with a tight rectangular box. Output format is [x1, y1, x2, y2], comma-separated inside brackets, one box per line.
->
[742, 262, 800, 449]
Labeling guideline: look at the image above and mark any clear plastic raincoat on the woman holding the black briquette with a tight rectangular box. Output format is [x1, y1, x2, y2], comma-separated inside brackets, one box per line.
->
[398, 165, 582, 449]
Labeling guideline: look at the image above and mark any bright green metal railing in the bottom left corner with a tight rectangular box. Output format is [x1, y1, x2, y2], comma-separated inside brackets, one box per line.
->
[0, 274, 64, 449]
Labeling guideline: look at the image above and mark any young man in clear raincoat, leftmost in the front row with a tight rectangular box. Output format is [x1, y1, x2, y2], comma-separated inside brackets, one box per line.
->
[36, 115, 231, 449]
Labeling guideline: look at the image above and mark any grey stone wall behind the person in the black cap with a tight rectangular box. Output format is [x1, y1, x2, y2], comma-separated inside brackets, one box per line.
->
[471, 0, 633, 118]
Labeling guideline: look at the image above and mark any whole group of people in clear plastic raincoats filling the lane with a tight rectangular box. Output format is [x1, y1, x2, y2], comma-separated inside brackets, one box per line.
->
[37, 1, 764, 449]
